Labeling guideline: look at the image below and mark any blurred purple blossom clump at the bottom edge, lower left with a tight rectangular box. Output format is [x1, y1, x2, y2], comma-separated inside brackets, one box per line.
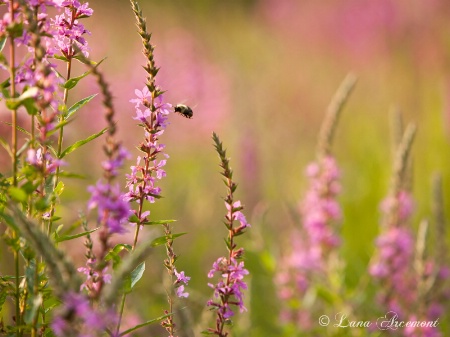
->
[51, 292, 116, 337]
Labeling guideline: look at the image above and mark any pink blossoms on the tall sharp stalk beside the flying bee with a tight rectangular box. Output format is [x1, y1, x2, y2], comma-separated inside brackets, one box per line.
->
[125, 87, 172, 203]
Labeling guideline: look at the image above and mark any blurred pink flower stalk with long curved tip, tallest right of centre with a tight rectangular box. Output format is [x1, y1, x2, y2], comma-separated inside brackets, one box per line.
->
[276, 74, 356, 330]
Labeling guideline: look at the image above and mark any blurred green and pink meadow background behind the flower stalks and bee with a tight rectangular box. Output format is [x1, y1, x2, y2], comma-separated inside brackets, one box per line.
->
[3, 0, 450, 336]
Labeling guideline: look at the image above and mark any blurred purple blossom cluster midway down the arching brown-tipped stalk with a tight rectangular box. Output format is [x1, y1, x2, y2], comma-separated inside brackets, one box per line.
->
[88, 181, 131, 234]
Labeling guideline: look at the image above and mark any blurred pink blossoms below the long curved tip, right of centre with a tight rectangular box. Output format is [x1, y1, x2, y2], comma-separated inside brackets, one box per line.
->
[275, 155, 341, 330]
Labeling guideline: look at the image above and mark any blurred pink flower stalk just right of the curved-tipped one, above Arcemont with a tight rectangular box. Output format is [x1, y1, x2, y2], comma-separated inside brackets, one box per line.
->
[369, 125, 417, 317]
